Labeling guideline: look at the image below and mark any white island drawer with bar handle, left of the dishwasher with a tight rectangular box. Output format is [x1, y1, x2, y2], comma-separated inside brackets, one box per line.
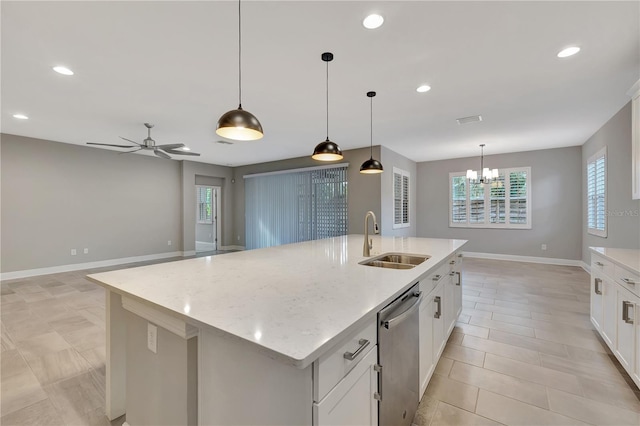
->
[313, 318, 378, 402]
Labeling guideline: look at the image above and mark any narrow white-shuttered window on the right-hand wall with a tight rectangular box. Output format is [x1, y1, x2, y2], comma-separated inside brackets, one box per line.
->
[587, 147, 607, 238]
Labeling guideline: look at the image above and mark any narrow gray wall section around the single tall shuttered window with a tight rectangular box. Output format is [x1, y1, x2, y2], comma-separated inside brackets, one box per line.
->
[380, 146, 418, 237]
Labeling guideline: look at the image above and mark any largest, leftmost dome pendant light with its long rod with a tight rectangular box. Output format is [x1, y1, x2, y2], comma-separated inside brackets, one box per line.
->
[216, 0, 264, 141]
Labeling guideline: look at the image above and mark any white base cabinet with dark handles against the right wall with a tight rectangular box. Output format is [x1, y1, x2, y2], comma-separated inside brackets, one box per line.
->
[591, 248, 640, 392]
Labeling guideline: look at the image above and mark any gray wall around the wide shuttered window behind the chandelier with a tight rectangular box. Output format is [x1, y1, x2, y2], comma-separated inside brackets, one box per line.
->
[417, 147, 584, 260]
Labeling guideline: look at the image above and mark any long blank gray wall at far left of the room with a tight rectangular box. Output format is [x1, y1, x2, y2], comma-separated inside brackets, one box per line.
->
[0, 134, 181, 272]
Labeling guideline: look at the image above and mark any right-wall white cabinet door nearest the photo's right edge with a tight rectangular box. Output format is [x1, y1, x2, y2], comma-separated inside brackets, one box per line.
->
[615, 286, 638, 372]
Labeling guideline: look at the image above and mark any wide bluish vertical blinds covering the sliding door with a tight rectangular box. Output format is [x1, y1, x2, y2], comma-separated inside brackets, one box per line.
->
[245, 164, 348, 249]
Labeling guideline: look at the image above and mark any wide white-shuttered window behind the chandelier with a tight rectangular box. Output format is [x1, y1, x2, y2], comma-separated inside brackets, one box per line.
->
[449, 167, 531, 229]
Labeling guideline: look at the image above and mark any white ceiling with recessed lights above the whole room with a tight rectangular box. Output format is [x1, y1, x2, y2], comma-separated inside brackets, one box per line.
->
[1, 1, 640, 166]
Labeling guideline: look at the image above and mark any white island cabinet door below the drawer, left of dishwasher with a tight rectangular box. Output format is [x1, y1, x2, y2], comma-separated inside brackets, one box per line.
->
[313, 346, 378, 426]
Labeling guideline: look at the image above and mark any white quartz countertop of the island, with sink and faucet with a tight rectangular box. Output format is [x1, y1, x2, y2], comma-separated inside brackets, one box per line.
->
[88, 235, 466, 368]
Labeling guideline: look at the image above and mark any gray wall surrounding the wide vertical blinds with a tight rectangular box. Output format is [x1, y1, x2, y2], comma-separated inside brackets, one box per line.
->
[233, 146, 384, 246]
